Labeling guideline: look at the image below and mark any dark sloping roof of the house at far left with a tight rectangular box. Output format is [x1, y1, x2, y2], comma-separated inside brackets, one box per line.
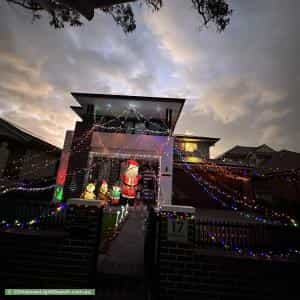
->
[0, 118, 61, 152]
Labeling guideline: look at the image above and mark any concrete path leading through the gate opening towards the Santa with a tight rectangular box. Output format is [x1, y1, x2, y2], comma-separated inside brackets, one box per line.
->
[94, 206, 148, 300]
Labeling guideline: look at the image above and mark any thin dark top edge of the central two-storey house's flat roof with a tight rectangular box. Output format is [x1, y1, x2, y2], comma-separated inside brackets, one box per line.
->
[71, 92, 185, 105]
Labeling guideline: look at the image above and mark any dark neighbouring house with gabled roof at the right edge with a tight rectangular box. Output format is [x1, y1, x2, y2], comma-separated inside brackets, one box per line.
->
[214, 145, 300, 216]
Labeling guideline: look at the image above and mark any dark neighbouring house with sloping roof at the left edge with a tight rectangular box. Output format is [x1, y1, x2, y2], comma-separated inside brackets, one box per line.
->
[0, 118, 61, 186]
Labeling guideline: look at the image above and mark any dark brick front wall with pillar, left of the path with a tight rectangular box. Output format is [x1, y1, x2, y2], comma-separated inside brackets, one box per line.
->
[0, 206, 102, 288]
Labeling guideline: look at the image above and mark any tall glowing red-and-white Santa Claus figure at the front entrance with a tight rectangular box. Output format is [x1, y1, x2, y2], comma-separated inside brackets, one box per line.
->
[122, 159, 141, 199]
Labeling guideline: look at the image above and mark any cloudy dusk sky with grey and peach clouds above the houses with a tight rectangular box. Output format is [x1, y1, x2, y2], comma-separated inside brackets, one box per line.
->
[0, 0, 300, 155]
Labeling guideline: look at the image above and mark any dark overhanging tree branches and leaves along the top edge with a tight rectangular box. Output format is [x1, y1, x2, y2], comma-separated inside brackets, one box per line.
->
[5, 0, 232, 33]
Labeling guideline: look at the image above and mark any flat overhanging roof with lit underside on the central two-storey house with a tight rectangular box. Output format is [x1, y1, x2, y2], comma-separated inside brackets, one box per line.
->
[71, 93, 185, 132]
